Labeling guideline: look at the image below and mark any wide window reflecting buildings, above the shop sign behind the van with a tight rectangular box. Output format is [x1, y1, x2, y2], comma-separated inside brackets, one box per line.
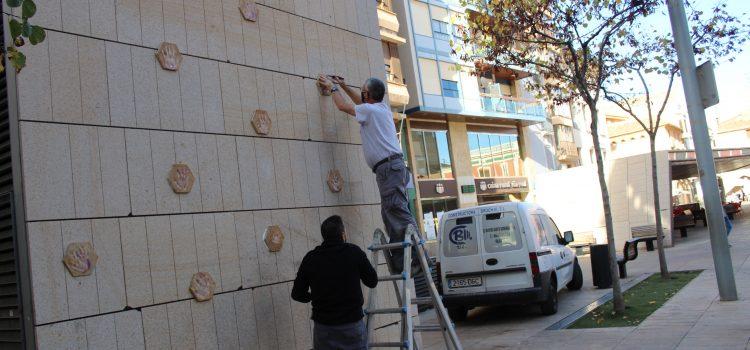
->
[467, 132, 521, 178]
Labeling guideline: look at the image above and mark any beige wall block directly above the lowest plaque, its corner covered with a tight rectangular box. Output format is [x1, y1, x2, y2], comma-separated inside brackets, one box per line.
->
[193, 214, 221, 287]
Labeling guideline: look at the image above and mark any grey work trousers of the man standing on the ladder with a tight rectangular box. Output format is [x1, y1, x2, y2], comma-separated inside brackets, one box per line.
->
[375, 159, 418, 271]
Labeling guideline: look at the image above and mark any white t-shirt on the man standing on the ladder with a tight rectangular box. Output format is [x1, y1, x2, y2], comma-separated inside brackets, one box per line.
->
[354, 102, 401, 168]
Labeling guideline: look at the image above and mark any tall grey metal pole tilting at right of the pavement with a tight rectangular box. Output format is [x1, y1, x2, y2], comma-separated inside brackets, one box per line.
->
[667, 0, 737, 301]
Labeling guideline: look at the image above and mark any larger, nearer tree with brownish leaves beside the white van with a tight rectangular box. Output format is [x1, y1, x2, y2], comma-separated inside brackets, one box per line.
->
[461, 0, 658, 313]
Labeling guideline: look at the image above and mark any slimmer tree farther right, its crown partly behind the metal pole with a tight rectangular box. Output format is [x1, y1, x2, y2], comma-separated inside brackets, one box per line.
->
[604, 3, 750, 279]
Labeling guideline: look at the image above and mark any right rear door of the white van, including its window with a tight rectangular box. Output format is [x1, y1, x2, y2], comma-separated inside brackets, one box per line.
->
[481, 211, 534, 292]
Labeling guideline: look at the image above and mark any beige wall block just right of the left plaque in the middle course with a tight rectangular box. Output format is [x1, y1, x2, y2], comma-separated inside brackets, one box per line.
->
[195, 134, 222, 211]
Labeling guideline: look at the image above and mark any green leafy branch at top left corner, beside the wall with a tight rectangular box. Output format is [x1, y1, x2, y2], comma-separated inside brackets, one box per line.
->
[0, 0, 46, 73]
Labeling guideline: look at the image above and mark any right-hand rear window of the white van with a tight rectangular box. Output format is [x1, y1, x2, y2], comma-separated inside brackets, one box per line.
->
[482, 212, 522, 253]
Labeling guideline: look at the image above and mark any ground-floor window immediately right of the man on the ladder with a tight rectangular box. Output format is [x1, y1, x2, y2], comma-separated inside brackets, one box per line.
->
[411, 130, 453, 179]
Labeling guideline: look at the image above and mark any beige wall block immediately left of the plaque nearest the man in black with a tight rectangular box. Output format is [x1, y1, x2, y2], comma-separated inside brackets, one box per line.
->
[234, 211, 260, 288]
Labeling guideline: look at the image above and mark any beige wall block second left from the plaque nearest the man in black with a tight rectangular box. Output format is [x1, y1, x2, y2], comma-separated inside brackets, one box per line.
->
[214, 213, 242, 291]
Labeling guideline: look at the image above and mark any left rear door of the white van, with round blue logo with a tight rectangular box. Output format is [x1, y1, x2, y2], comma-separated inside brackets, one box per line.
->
[440, 215, 485, 294]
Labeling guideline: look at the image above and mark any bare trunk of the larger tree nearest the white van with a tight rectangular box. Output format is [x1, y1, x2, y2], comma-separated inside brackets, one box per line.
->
[589, 104, 625, 314]
